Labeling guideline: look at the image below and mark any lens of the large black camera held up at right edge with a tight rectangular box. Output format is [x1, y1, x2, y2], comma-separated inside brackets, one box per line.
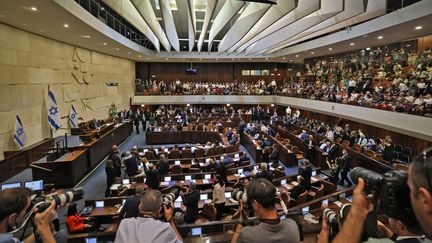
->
[351, 167, 384, 194]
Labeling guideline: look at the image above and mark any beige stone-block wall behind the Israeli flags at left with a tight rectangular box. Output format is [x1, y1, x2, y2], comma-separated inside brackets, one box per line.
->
[0, 24, 135, 159]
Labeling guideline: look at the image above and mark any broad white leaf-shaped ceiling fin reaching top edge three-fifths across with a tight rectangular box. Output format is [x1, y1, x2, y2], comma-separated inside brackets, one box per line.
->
[218, 3, 272, 53]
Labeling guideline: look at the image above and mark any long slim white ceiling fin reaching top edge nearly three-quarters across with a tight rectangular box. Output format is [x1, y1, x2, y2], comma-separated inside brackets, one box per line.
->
[236, 0, 321, 54]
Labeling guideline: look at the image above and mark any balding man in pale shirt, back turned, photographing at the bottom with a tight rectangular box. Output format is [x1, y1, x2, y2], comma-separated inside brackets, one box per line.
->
[115, 190, 182, 243]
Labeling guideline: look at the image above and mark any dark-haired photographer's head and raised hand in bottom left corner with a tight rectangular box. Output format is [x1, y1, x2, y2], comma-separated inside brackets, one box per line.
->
[0, 187, 55, 243]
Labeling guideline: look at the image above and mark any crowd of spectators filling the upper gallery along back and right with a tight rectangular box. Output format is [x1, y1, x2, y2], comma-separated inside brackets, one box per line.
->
[137, 47, 432, 117]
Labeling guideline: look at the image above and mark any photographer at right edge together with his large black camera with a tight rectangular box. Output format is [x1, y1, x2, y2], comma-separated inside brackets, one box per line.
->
[318, 148, 432, 243]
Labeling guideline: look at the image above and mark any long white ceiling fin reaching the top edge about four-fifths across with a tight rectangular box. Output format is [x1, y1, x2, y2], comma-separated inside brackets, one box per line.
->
[246, 0, 344, 54]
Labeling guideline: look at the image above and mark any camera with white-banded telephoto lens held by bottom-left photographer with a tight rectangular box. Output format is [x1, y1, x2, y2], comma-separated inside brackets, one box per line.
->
[32, 188, 84, 212]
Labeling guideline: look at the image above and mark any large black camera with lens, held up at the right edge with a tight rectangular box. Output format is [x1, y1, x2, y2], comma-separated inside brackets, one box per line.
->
[351, 167, 416, 222]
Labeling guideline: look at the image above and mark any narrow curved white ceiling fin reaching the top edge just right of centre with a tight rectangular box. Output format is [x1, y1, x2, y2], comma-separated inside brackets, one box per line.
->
[208, 1, 245, 50]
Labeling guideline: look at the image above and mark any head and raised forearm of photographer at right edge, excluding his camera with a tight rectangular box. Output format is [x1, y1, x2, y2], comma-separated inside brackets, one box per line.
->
[318, 148, 432, 243]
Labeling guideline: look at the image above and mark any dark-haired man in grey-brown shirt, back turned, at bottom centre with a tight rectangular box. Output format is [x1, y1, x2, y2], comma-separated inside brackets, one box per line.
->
[231, 179, 300, 243]
